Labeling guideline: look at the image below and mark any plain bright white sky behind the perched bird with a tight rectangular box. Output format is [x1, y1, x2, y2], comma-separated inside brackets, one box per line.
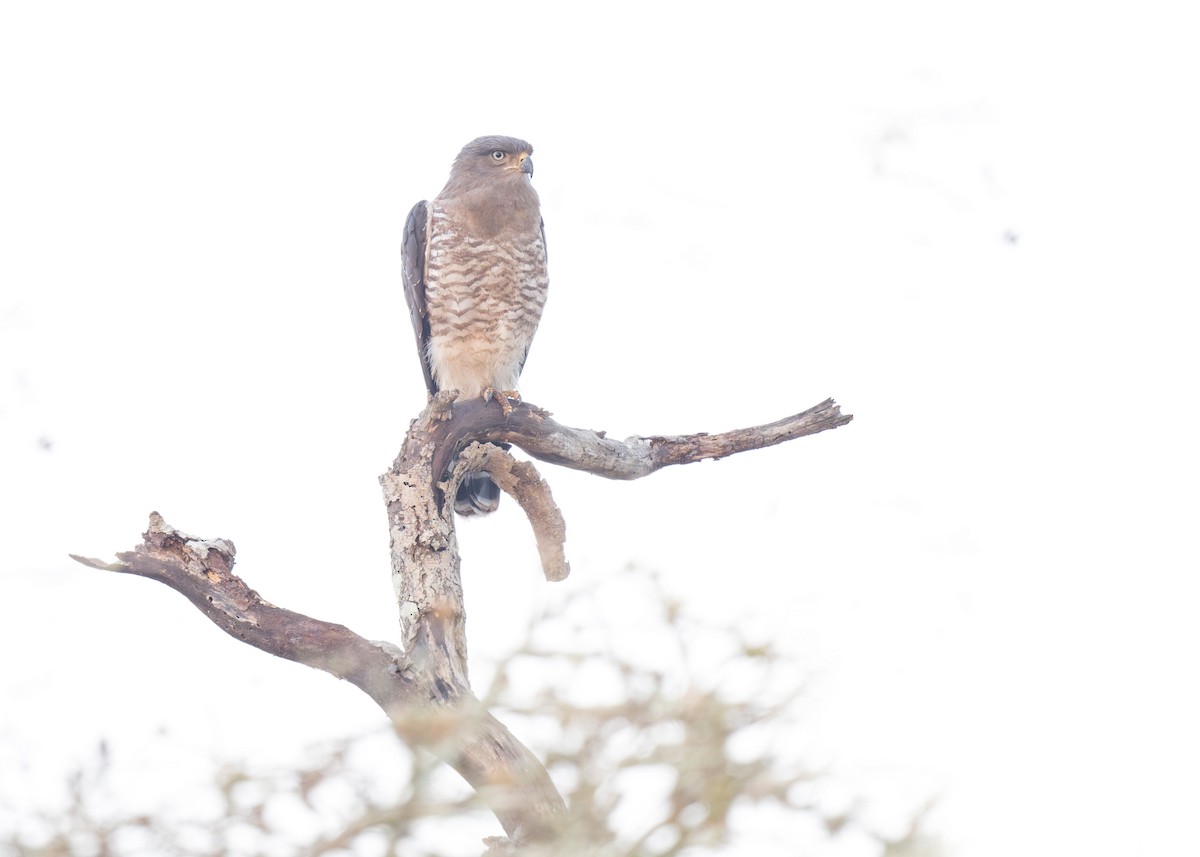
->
[0, 2, 1200, 857]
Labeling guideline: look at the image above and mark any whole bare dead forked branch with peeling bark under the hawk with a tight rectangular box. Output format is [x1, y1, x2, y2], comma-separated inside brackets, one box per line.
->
[73, 392, 852, 853]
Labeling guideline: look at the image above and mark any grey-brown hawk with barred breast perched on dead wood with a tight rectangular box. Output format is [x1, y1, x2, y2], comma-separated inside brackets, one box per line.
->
[403, 137, 550, 515]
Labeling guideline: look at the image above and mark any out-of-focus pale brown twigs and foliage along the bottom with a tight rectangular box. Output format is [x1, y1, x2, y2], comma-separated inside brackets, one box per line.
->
[0, 573, 943, 857]
